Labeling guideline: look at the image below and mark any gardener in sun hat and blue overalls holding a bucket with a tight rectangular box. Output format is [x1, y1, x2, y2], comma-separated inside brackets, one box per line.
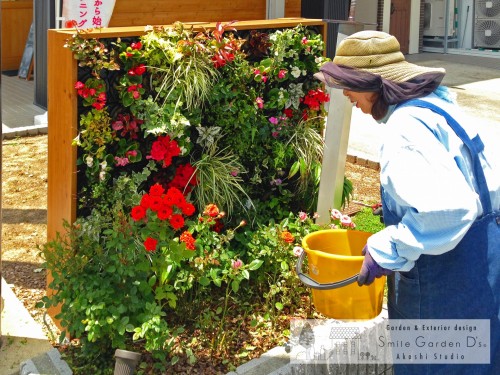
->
[316, 31, 500, 375]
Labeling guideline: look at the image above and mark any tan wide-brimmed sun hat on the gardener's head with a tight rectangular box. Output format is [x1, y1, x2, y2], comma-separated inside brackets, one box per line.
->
[315, 30, 445, 87]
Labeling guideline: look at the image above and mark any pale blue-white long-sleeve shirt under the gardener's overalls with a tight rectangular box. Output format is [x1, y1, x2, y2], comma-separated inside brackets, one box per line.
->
[368, 94, 500, 271]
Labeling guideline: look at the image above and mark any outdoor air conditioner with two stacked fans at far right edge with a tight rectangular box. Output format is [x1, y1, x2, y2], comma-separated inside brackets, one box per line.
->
[474, 0, 500, 49]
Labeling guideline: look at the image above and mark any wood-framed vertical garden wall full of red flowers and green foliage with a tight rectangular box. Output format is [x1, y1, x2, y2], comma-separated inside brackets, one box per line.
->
[43, 19, 348, 370]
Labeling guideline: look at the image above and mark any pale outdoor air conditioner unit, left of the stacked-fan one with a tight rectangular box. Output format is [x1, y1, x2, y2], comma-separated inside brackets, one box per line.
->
[424, 0, 455, 37]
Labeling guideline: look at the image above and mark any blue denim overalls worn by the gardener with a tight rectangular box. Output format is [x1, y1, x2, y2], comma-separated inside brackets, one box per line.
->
[382, 100, 500, 375]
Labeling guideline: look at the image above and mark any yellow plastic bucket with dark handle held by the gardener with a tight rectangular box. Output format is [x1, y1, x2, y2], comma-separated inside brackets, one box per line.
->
[296, 229, 386, 320]
